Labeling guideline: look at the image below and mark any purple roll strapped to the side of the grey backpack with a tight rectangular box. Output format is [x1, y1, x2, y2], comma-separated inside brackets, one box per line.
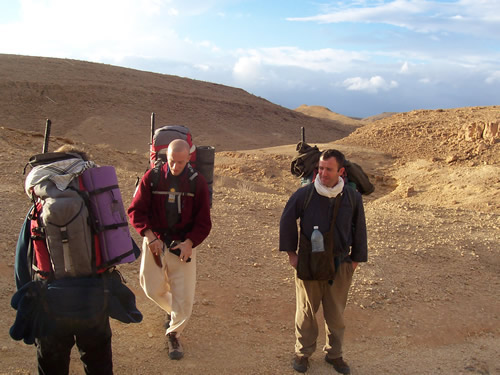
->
[81, 166, 136, 268]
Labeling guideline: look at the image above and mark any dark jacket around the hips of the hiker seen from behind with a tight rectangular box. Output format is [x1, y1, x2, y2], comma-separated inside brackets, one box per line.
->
[9, 273, 142, 344]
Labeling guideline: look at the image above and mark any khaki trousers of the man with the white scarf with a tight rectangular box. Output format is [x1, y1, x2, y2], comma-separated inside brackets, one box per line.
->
[295, 262, 353, 359]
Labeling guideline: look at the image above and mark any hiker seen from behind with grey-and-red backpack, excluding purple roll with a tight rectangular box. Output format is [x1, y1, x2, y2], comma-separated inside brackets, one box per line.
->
[9, 145, 142, 375]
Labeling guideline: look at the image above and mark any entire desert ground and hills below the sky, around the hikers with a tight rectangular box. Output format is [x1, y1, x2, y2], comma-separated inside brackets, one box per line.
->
[0, 55, 500, 375]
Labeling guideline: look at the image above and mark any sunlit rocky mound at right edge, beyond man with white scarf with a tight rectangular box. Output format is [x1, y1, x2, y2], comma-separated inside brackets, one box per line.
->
[340, 106, 500, 165]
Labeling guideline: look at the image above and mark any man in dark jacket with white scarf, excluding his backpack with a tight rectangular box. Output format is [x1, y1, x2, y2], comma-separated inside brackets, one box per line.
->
[280, 150, 367, 374]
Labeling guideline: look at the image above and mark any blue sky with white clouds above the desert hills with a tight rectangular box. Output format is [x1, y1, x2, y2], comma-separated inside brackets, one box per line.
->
[0, 0, 500, 117]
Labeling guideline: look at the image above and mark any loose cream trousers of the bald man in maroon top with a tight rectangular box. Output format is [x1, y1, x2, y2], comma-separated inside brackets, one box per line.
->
[139, 239, 196, 337]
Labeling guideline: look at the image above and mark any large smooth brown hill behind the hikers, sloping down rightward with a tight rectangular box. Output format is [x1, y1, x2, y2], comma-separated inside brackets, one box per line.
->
[0, 54, 360, 151]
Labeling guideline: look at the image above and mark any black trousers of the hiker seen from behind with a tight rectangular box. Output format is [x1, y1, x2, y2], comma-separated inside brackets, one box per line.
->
[36, 314, 113, 375]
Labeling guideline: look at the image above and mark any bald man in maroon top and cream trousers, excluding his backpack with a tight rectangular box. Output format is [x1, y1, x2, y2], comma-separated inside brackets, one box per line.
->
[128, 139, 212, 360]
